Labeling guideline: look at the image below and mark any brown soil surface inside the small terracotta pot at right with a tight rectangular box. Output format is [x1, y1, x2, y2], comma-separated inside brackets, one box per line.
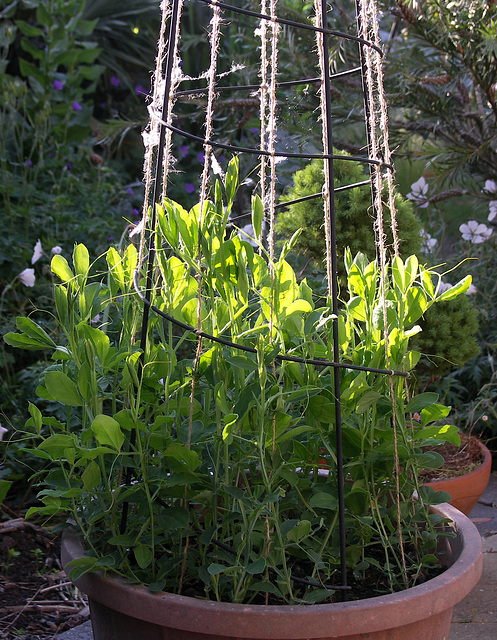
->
[419, 433, 485, 482]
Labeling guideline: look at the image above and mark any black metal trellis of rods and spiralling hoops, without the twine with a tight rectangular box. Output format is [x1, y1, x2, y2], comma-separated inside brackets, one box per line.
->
[127, 0, 407, 595]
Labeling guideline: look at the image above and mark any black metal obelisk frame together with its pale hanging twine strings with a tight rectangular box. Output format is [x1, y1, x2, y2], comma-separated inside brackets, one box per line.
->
[130, 0, 402, 597]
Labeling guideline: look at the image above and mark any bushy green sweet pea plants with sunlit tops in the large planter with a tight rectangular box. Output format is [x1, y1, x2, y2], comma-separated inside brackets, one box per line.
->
[5, 159, 469, 603]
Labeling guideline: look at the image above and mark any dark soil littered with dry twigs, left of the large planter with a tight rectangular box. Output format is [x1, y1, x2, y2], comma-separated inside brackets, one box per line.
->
[0, 518, 89, 640]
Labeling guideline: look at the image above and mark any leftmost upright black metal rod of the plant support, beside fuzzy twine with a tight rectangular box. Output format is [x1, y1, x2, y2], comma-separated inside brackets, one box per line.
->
[119, 0, 180, 533]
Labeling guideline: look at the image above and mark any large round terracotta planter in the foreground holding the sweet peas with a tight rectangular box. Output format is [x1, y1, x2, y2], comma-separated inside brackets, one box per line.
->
[62, 504, 482, 640]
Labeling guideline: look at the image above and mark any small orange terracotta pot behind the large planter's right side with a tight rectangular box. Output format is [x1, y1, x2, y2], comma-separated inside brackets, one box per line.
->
[424, 441, 492, 516]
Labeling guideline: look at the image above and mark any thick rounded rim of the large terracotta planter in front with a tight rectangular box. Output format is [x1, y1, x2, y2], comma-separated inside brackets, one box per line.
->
[62, 504, 482, 640]
